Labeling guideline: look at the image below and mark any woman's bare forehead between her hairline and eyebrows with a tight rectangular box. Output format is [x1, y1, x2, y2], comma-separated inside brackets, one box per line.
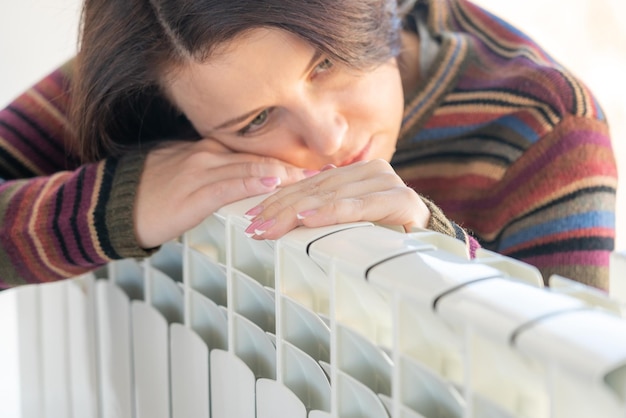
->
[165, 28, 315, 126]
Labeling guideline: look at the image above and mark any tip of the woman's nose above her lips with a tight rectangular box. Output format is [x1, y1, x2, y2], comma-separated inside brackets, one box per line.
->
[302, 106, 348, 156]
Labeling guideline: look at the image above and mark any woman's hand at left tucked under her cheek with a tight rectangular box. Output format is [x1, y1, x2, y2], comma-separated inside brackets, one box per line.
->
[134, 139, 307, 248]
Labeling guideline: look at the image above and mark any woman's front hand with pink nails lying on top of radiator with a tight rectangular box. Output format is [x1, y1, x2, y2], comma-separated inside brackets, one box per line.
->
[246, 160, 430, 239]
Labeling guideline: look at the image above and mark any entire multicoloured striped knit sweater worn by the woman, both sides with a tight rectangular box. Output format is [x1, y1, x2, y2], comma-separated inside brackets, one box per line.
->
[0, 0, 617, 288]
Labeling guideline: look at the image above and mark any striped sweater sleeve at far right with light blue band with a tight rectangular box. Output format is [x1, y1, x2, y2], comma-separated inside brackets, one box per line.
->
[482, 115, 617, 290]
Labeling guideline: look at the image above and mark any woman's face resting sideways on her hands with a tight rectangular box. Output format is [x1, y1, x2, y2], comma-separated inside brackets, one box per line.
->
[167, 29, 404, 169]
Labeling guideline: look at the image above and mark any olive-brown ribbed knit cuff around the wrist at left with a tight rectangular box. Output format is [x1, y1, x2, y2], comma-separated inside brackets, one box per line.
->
[106, 151, 158, 258]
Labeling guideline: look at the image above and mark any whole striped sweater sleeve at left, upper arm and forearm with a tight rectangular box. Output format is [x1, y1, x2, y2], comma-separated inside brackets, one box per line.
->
[0, 63, 154, 288]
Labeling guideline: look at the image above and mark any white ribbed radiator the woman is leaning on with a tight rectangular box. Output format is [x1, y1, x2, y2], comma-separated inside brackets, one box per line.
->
[0, 199, 626, 418]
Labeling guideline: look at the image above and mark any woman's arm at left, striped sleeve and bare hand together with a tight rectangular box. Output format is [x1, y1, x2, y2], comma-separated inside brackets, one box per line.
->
[0, 62, 312, 288]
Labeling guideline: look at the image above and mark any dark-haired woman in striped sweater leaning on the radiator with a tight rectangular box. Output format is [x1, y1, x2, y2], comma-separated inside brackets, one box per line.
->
[0, 0, 616, 289]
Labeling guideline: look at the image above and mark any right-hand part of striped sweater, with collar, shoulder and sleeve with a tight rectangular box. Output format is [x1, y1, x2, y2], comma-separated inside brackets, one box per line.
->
[392, 0, 617, 289]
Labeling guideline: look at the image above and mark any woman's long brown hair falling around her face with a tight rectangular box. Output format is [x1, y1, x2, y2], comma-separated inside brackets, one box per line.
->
[72, 0, 414, 161]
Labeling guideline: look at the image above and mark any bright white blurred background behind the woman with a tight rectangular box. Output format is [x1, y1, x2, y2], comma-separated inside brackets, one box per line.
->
[0, 0, 626, 250]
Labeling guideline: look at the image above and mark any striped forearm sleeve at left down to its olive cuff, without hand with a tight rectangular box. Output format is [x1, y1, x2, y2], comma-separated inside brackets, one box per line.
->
[0, 155, 148, 287]
